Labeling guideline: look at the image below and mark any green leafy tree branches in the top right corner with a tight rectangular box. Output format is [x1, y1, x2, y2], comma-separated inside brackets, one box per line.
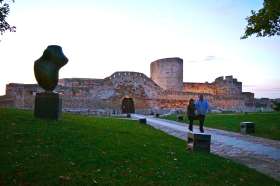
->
[241, 0, 280, 39]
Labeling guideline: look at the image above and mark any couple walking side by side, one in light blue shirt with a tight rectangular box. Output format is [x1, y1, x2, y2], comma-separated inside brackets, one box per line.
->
[187, 94, 209, 133]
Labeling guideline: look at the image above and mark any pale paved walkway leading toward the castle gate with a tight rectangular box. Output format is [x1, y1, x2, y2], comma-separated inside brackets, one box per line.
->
[132, 114, 280, 181]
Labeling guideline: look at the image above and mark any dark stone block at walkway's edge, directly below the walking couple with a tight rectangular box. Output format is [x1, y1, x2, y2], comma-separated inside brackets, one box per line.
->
[187, 132, 211, 152]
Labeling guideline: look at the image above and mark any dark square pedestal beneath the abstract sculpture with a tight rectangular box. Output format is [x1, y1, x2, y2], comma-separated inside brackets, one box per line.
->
[34, 92, 62, 120]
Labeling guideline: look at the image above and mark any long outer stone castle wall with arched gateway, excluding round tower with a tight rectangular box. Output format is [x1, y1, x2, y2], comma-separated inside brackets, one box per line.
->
[0, 76, 264, 112]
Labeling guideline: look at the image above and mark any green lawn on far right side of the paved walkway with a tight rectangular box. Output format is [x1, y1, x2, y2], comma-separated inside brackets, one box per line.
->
[162, 112, 280, 140]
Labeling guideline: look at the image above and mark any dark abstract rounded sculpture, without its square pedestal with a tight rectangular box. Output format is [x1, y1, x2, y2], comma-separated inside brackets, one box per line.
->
[34, 45, 68, 91]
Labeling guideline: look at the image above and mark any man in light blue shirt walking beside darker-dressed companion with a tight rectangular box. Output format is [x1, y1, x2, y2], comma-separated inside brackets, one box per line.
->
[195, 94, 209, 133]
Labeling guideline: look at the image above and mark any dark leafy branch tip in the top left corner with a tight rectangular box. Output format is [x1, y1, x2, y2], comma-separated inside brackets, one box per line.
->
[0, 0, 16, 35]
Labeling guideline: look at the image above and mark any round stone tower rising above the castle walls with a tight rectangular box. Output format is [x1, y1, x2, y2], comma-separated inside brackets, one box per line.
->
[150, 57, 183, 91]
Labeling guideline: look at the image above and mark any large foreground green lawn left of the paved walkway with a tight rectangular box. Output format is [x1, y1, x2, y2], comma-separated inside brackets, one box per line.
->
[0, 109, 280, 186]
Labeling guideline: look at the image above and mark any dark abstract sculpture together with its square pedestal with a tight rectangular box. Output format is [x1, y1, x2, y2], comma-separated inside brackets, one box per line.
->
[34, 45, 68, 120]
